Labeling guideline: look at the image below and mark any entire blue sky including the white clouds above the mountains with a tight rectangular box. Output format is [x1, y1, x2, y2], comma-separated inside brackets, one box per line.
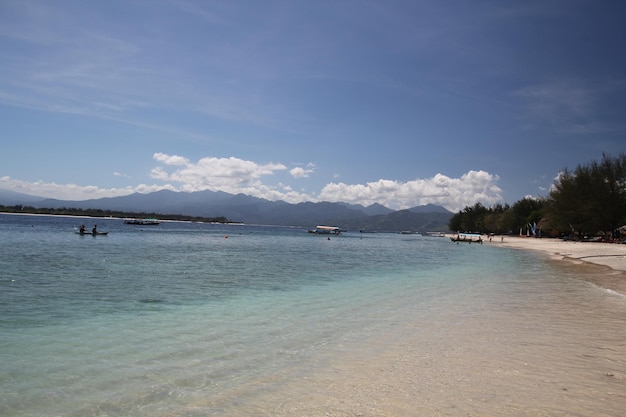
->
[0, 0, 626, 211]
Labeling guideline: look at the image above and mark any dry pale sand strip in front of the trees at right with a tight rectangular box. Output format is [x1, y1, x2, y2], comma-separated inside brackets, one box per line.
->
[492, 236, 626, 296]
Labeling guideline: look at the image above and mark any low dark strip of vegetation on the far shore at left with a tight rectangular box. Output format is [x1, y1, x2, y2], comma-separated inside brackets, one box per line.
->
[0, 205, 233, 223]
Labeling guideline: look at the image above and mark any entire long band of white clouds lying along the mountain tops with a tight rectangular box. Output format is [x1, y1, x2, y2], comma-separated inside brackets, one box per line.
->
[0, 161, 502, 211]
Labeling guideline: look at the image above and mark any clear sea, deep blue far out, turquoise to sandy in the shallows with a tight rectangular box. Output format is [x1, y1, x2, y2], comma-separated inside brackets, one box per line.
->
[0, 214, 626, 417]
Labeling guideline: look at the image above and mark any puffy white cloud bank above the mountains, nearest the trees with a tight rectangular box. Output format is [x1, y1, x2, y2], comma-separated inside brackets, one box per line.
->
[318, 171, 502, 211]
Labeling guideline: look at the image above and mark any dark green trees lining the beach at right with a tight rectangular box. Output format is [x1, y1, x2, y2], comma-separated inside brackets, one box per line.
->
[448, 153, 626, 238]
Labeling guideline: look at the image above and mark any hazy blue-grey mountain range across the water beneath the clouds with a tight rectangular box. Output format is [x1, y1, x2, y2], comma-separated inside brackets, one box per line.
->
[0, 190, 453, 232]
